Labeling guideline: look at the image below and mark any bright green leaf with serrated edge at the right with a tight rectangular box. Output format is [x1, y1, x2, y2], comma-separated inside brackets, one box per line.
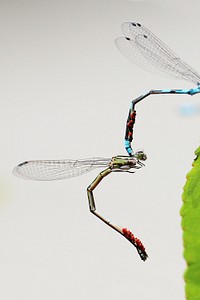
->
[181, 147, 200, 300]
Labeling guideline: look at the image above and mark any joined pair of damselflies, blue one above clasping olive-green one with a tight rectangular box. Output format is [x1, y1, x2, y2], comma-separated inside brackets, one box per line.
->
[13, 22, 200, 261]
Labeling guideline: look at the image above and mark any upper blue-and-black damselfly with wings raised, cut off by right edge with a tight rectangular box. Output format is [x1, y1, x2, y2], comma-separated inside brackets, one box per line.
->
[115, 22, 200, 156]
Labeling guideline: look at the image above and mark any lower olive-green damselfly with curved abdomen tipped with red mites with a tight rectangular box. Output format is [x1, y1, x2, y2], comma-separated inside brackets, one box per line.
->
[13, 151, 148, 261]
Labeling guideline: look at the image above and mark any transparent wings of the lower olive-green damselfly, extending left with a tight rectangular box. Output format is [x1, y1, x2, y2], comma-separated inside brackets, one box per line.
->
[13, 157, 111, 180]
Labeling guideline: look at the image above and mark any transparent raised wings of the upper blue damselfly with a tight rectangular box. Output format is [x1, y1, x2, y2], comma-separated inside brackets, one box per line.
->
[115, 22, 200, 85]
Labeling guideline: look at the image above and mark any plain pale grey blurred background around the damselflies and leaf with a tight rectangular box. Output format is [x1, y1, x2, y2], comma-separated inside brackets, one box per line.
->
[0, 0, 200, 300]
